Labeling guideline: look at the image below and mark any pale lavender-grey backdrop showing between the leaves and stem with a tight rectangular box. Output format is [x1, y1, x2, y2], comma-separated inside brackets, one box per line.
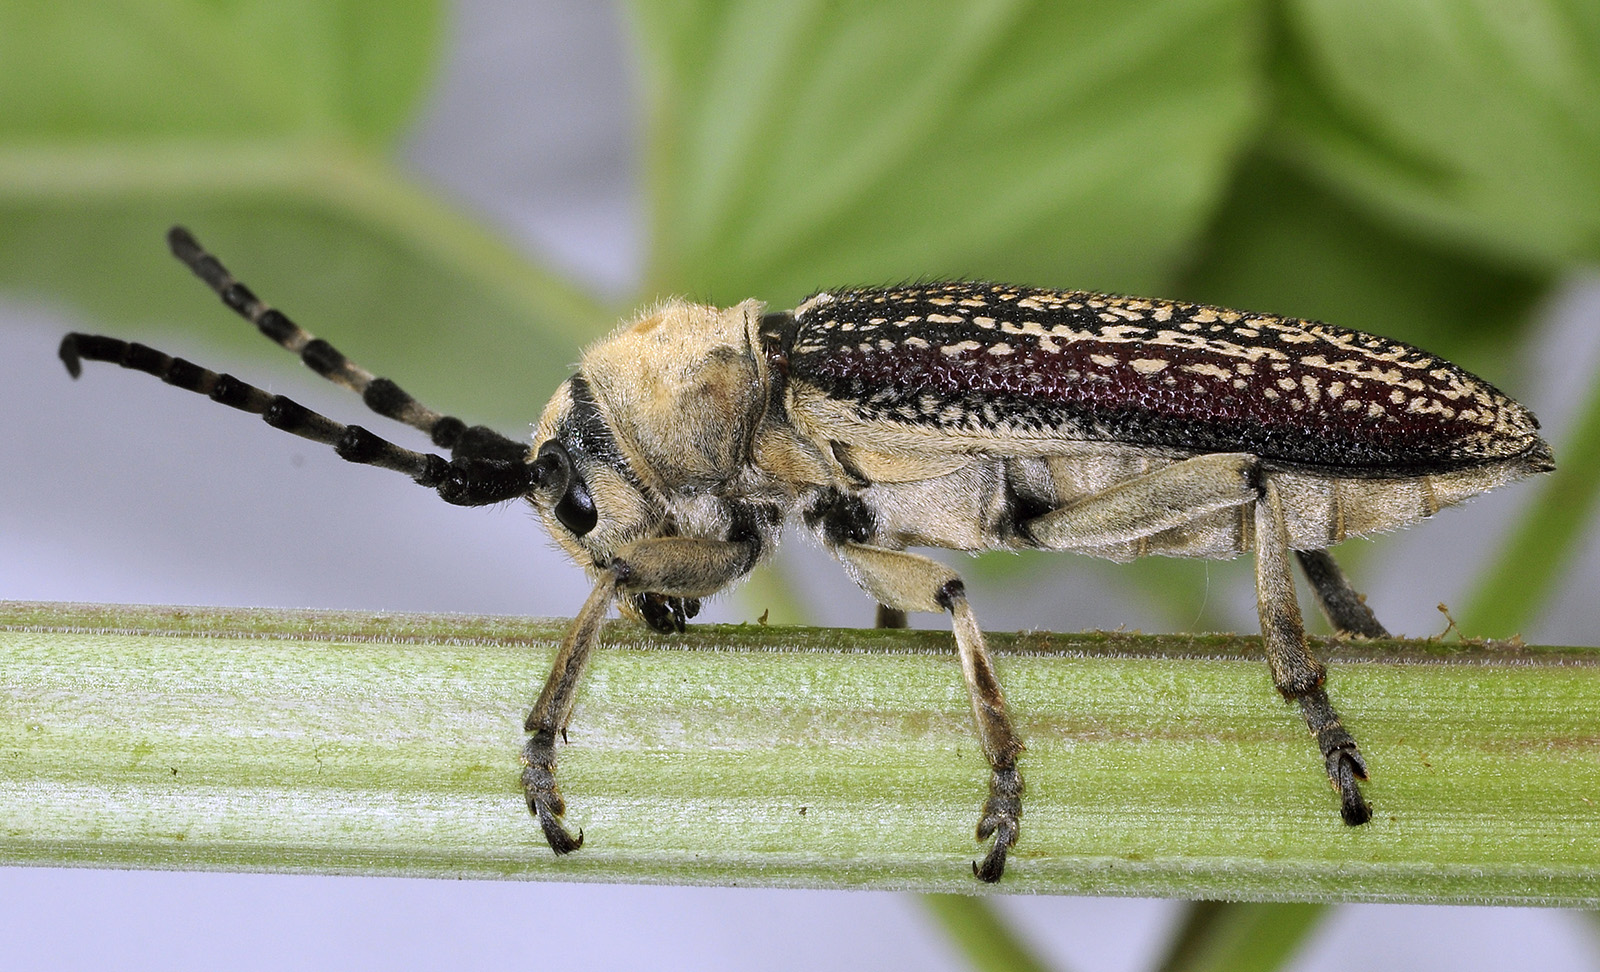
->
[0, 0, 1600, 972]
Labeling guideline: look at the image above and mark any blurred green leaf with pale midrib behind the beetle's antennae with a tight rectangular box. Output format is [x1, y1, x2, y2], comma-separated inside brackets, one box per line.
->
[0, 0, 610, 422]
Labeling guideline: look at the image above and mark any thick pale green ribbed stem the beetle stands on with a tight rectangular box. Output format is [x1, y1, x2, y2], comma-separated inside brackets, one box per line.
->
[0, 604, 1600, 906]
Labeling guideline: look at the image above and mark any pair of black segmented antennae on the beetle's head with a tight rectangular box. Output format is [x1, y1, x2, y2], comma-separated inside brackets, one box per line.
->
[61, 227, 555, 507]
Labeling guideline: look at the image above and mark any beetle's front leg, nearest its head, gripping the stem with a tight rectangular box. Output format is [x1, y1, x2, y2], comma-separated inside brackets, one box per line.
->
[522, 537, 760, 854]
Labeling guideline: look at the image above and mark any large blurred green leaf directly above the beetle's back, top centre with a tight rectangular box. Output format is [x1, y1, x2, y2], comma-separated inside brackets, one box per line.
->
[634, 0, 1261, 305]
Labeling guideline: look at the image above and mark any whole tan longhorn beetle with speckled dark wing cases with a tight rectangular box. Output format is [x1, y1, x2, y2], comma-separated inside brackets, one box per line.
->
[61, 227, 1554, 881]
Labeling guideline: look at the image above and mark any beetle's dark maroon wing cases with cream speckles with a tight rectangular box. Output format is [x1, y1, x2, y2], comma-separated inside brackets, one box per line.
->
[789, 281, 1539, 475]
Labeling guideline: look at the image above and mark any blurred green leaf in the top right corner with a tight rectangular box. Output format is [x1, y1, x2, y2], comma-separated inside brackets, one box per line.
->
[1274, 0, 1600, 272]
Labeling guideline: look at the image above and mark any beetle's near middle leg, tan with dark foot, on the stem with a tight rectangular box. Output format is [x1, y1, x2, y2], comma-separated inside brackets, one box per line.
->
[834, 544, 1022, 882]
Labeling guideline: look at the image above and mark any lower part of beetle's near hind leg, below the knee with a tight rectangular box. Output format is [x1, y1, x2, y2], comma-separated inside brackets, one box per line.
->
[1256, 476, 1373, 827]
